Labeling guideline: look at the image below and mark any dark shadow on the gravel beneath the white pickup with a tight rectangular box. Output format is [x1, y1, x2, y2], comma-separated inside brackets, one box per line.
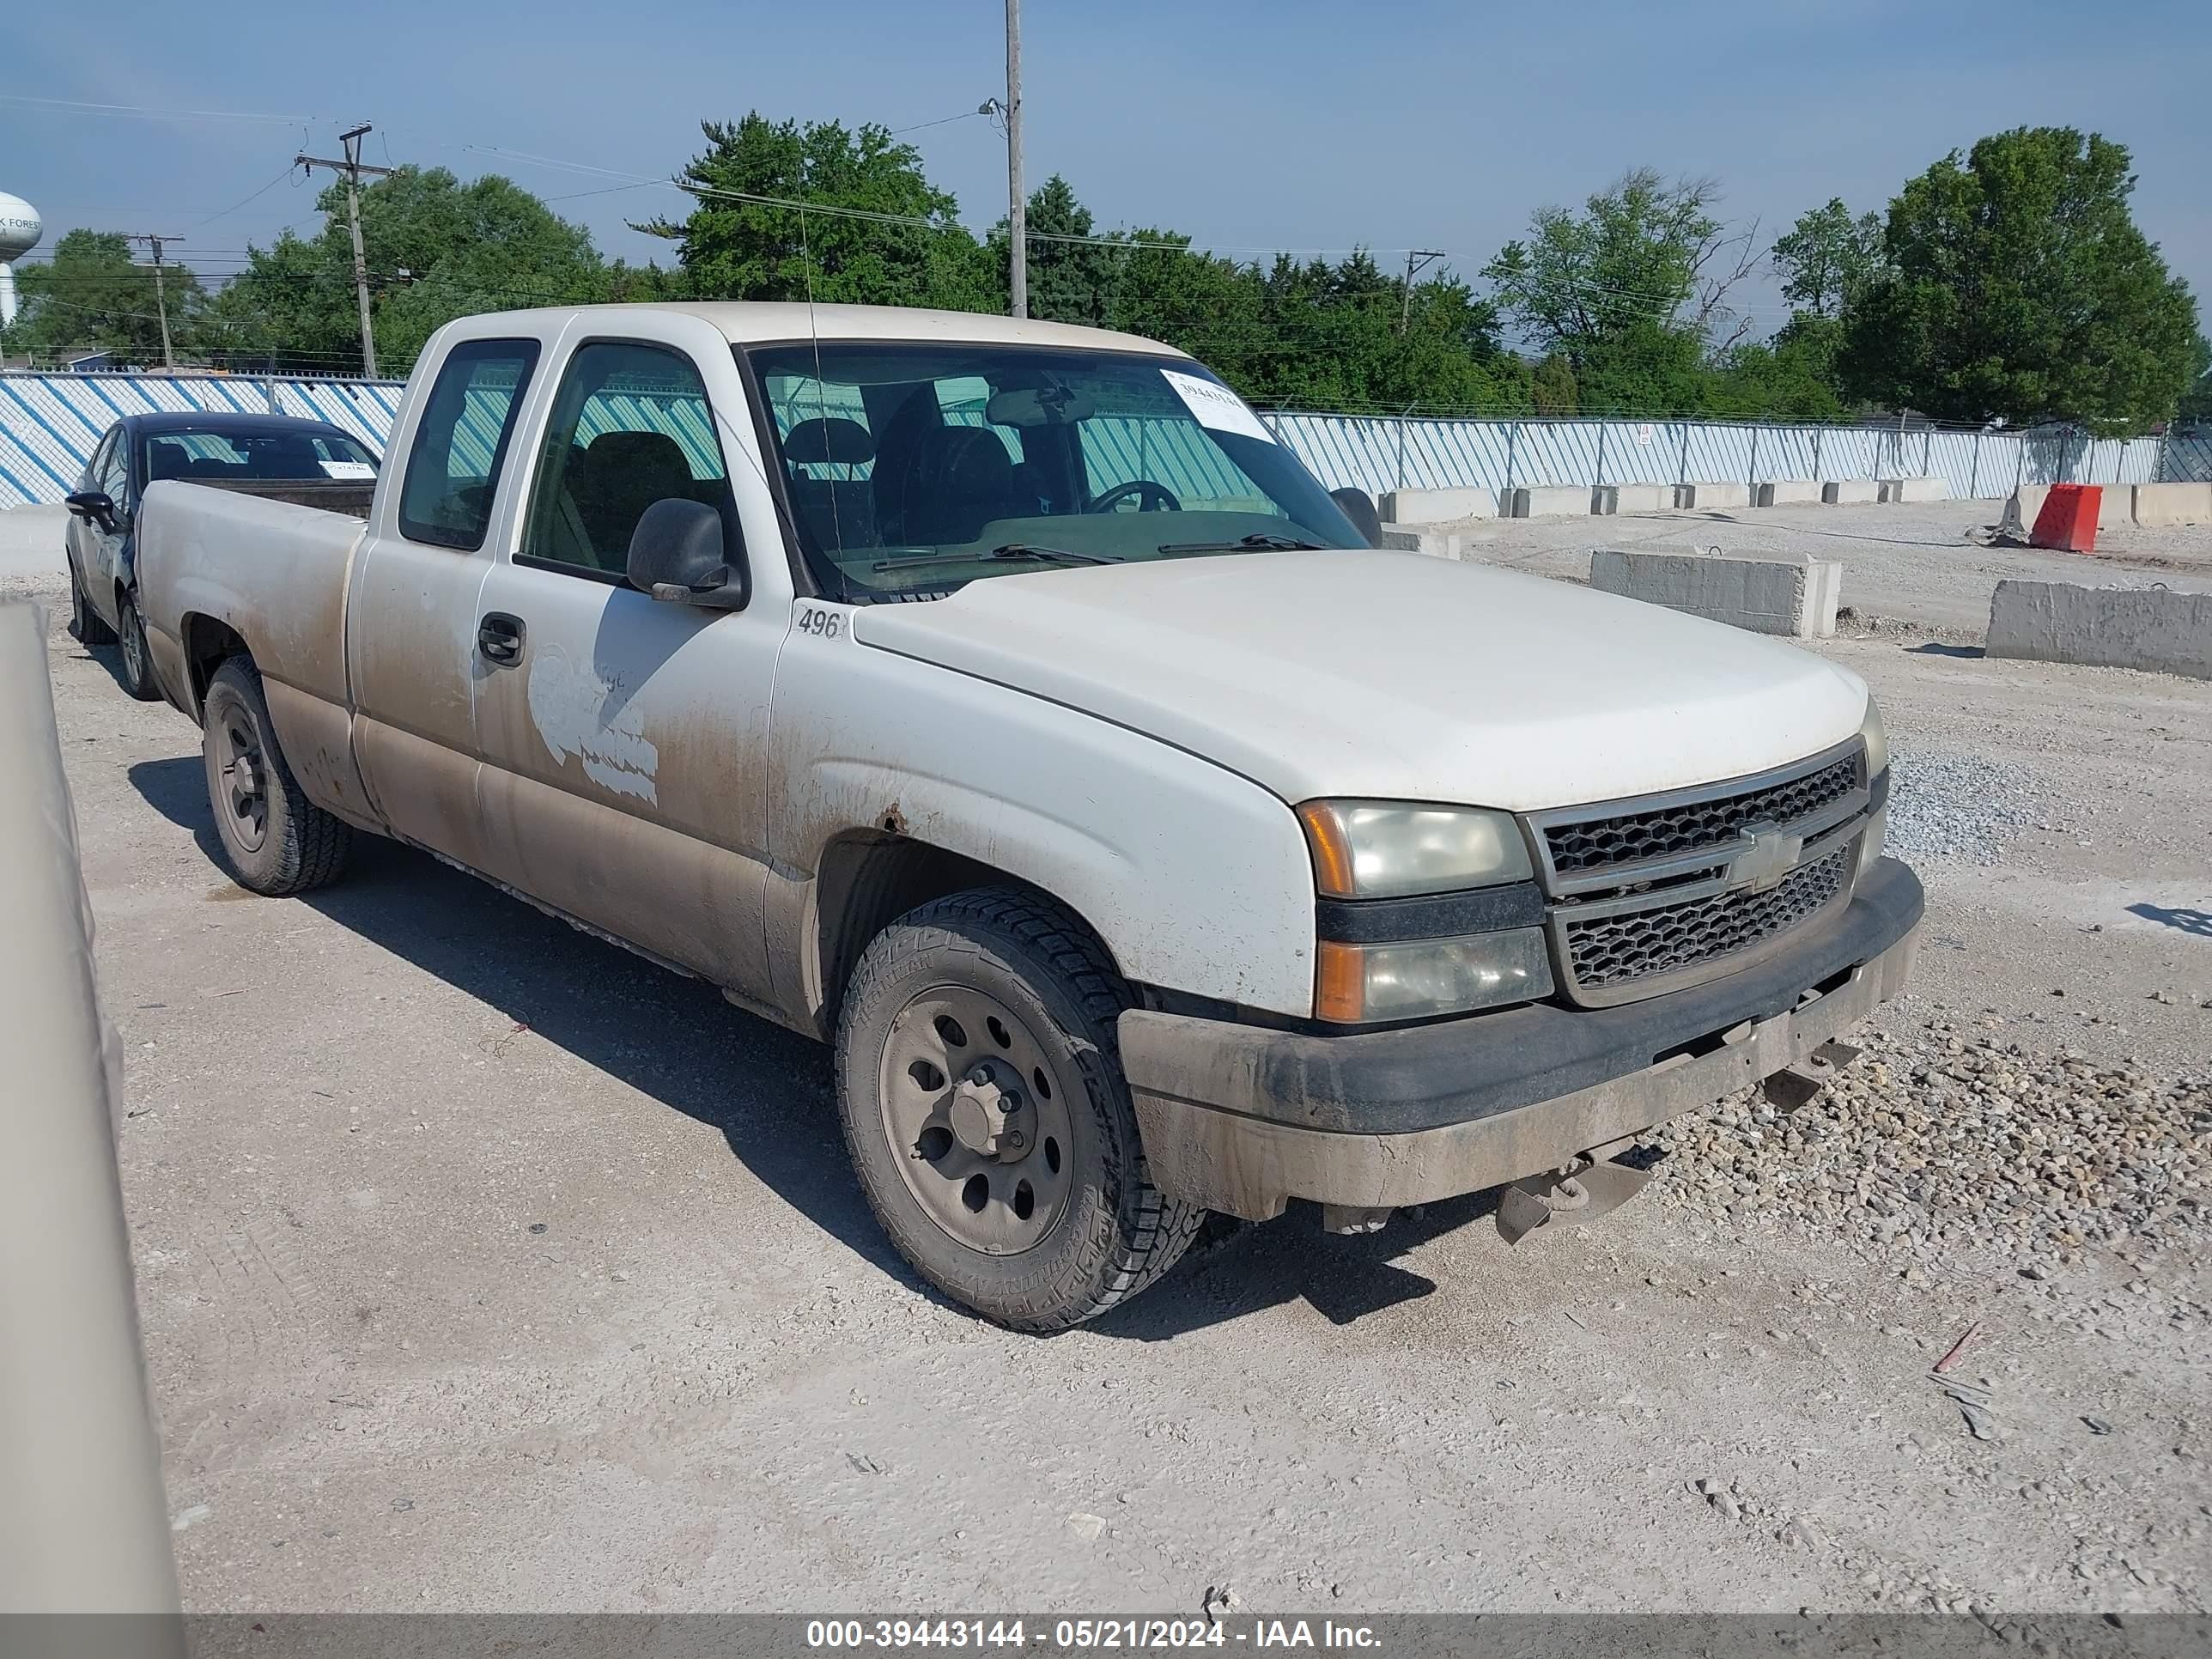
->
[128, 754, 1522, 1340]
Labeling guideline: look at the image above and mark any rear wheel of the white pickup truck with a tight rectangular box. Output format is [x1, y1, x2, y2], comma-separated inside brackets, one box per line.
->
[199, 657, 354, 898]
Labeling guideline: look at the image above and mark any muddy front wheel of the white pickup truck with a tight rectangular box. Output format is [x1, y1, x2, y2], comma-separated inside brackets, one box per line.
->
[836, 887, 1206, 1332]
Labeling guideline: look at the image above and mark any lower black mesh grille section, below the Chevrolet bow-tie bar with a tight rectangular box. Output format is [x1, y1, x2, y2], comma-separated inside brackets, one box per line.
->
[1562, 841, 1858, 1000]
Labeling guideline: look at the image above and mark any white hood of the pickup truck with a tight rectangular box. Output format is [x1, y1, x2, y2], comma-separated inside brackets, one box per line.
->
[852, 550, 1867, 811]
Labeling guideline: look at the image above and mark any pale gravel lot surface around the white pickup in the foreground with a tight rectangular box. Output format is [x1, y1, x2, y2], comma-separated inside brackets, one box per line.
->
[0, 508, 2212, 1614]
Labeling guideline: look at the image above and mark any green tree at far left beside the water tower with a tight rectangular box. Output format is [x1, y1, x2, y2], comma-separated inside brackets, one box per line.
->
[4, 230, 206, 365]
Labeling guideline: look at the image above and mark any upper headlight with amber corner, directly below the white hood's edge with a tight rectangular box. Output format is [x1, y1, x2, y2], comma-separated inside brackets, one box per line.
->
[1298, 801, 1533, 898]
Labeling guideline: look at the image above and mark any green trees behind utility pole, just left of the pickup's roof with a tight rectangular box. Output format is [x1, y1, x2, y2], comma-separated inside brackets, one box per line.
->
[208, 168, 615, 374]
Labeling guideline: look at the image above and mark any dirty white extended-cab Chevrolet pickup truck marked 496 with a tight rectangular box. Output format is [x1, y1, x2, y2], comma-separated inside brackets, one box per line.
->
[139, 305, 1923, 1329]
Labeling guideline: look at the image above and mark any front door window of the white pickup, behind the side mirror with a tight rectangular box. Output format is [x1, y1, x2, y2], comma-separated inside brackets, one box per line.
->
[515, 341, 732, 581]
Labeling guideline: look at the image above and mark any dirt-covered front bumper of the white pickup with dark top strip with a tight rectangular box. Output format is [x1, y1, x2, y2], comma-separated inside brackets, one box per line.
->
[1121, 858, 1923, 1221]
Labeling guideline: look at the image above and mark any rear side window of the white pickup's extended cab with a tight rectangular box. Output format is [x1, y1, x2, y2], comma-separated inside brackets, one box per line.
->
[400, 341, 538, 553]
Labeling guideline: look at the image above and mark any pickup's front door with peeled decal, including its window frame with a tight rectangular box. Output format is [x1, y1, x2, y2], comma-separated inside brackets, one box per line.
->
[462, 314, 792, 1000]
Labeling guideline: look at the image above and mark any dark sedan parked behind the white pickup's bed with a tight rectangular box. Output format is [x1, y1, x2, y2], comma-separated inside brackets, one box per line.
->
[64, 410, 376, 702]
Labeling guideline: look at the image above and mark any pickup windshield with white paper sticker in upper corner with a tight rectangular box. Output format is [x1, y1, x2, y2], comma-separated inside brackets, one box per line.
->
[748, 341, 1364, 599]
